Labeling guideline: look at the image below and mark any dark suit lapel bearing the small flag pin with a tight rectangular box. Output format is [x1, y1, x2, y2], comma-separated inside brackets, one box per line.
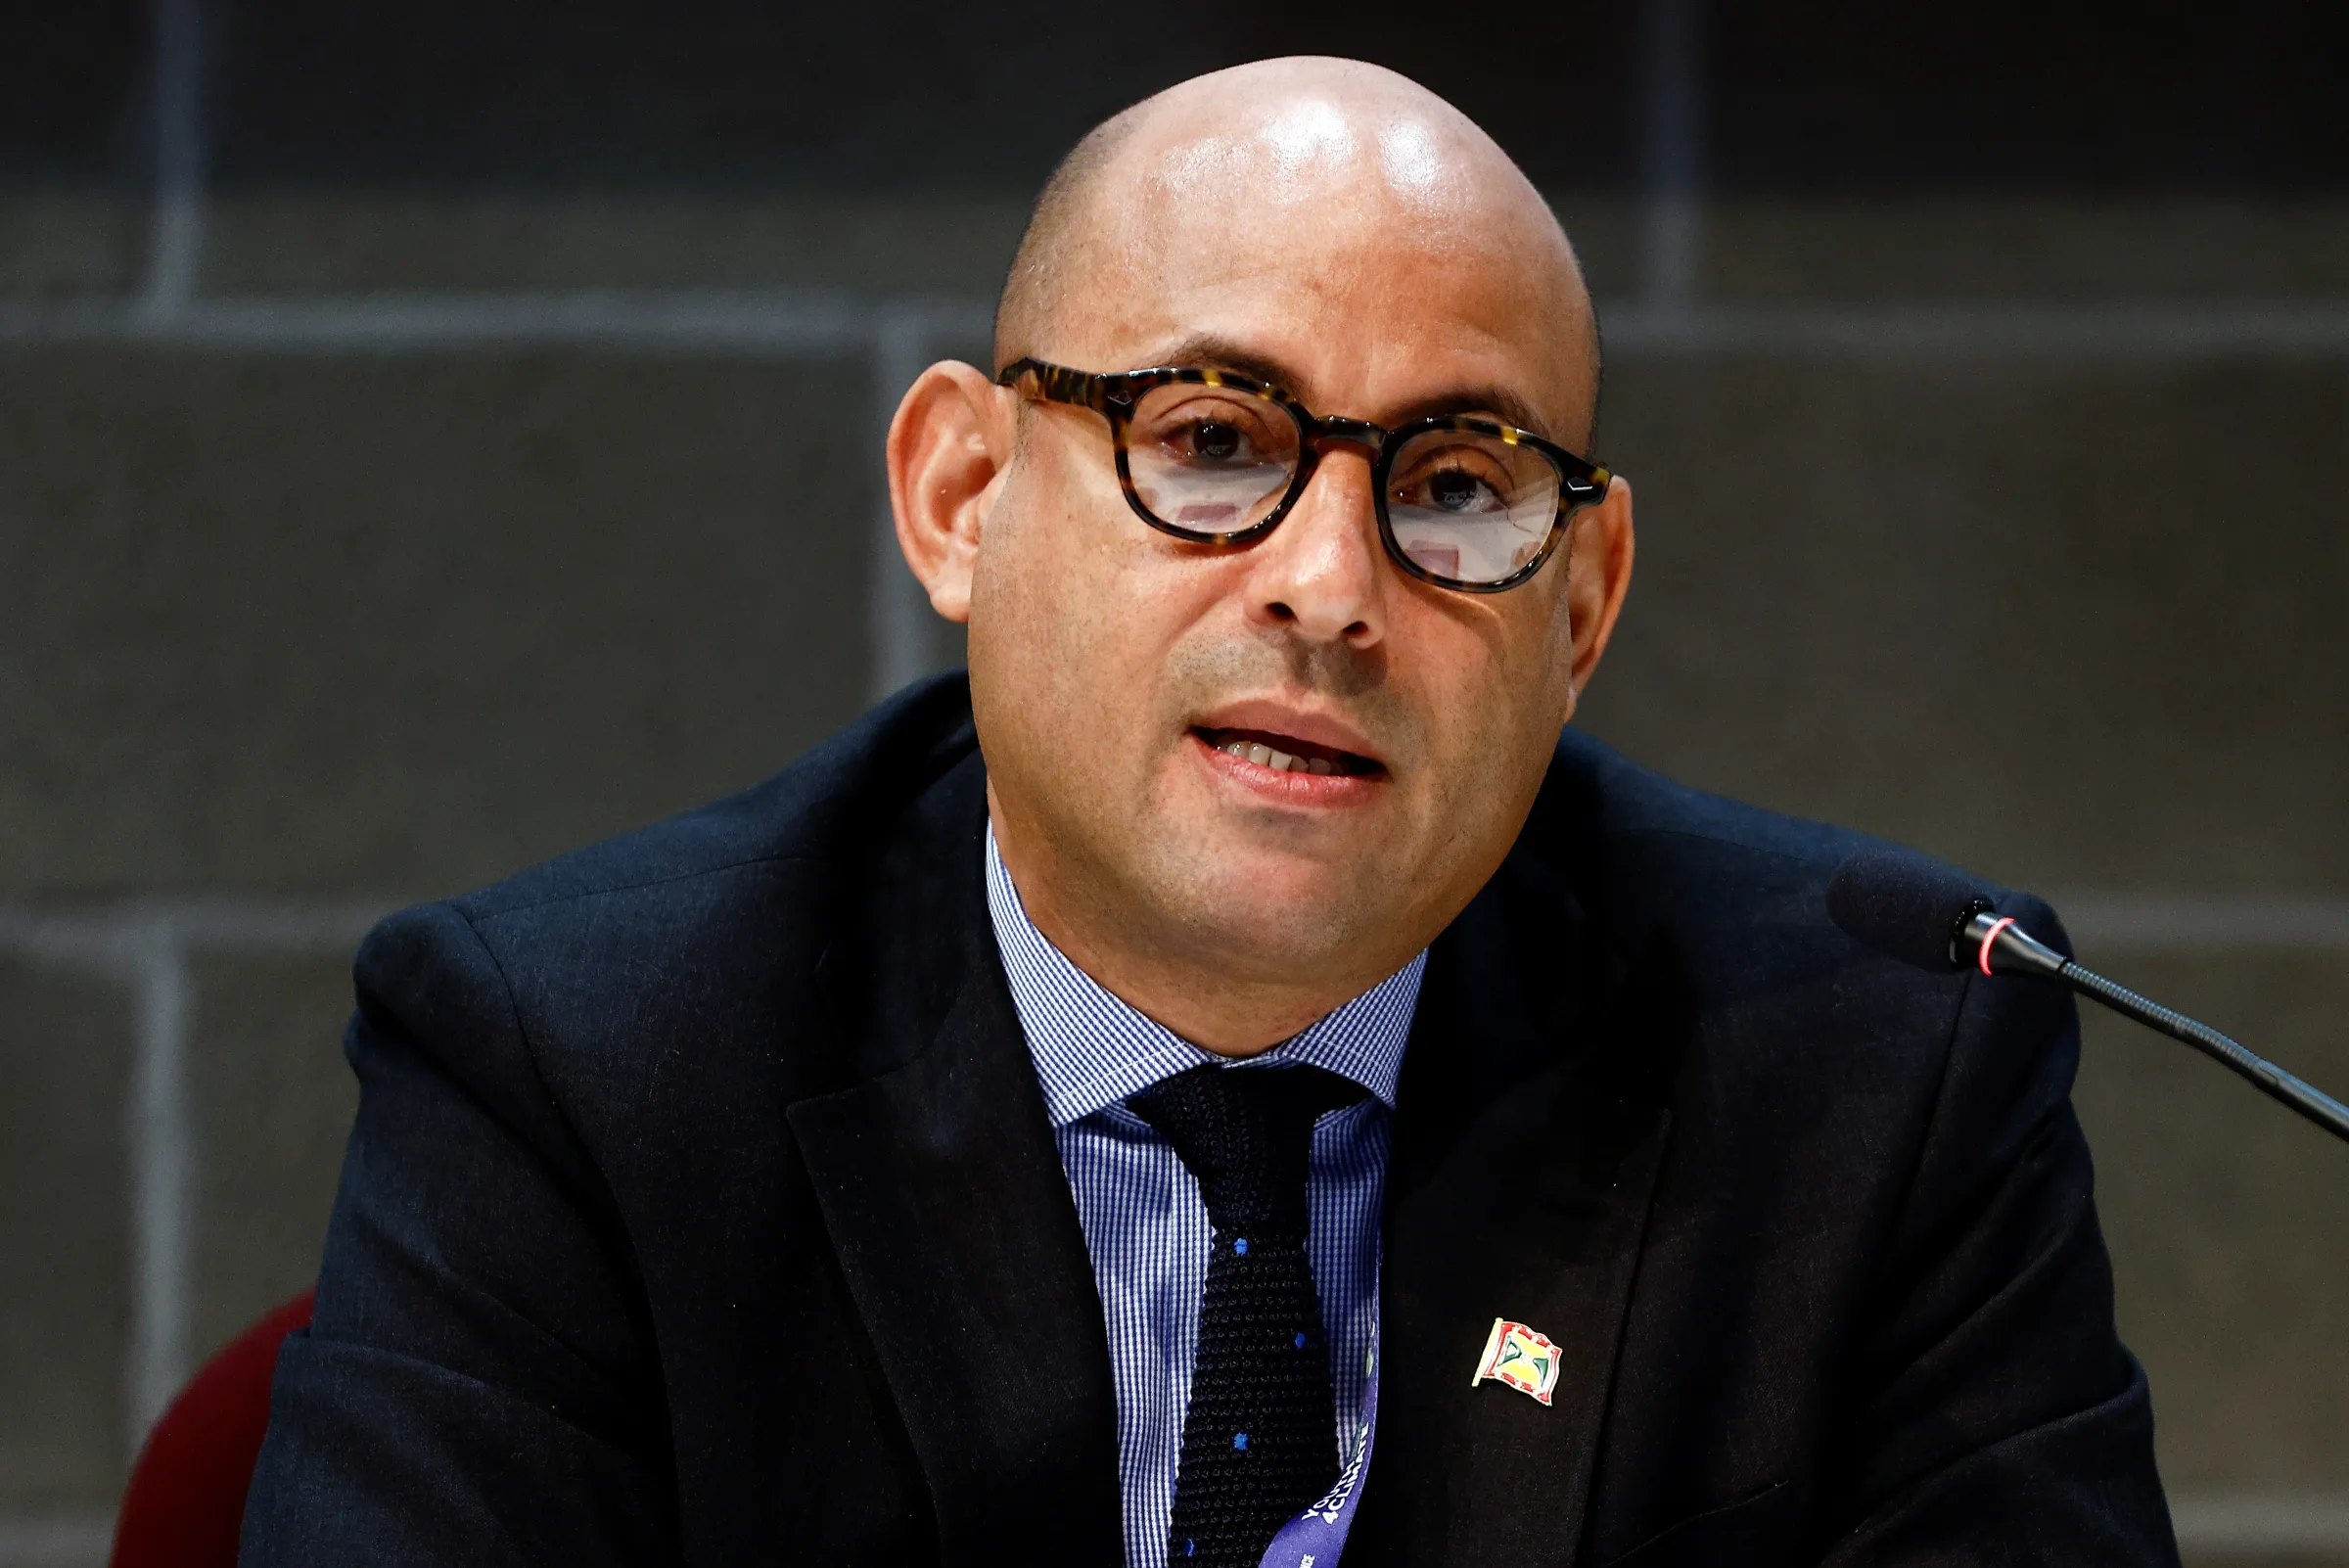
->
[1349, 854, 1670, 1568]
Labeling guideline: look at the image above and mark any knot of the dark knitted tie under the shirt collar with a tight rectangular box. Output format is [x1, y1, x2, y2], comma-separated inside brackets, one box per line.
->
[1126, 1066, 1367, 1237]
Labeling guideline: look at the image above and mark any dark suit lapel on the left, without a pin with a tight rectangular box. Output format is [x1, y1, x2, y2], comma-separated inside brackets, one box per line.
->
[787, 761, 1121, 1563]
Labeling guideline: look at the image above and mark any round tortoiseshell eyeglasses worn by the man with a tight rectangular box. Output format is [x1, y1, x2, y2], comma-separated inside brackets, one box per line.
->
[996, 359, 1611, 594]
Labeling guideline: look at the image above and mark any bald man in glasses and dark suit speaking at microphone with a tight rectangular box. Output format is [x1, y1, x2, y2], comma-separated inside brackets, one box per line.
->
[245, 61, 2175, 1568]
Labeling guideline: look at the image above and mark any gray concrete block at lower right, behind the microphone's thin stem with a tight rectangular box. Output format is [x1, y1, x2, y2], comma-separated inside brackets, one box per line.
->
[2077, 953, 2349, 1496]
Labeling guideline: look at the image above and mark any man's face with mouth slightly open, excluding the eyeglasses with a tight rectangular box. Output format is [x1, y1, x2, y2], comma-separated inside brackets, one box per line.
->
[970, 104, 1590, 1004]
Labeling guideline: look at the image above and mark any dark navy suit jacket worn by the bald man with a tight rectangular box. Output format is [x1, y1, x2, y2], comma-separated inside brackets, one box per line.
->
[245, 676, 2175, 1568]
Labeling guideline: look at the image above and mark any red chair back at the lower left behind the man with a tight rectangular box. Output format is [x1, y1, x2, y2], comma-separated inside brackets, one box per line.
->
[111, 1291, 312, 1568]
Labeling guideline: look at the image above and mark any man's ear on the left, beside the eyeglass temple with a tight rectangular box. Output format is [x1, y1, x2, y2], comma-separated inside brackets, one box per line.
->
[888, 359, 1017, 623]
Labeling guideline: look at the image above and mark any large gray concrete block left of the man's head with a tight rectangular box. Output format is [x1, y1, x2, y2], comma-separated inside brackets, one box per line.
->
[0, 346, 879, 899]
